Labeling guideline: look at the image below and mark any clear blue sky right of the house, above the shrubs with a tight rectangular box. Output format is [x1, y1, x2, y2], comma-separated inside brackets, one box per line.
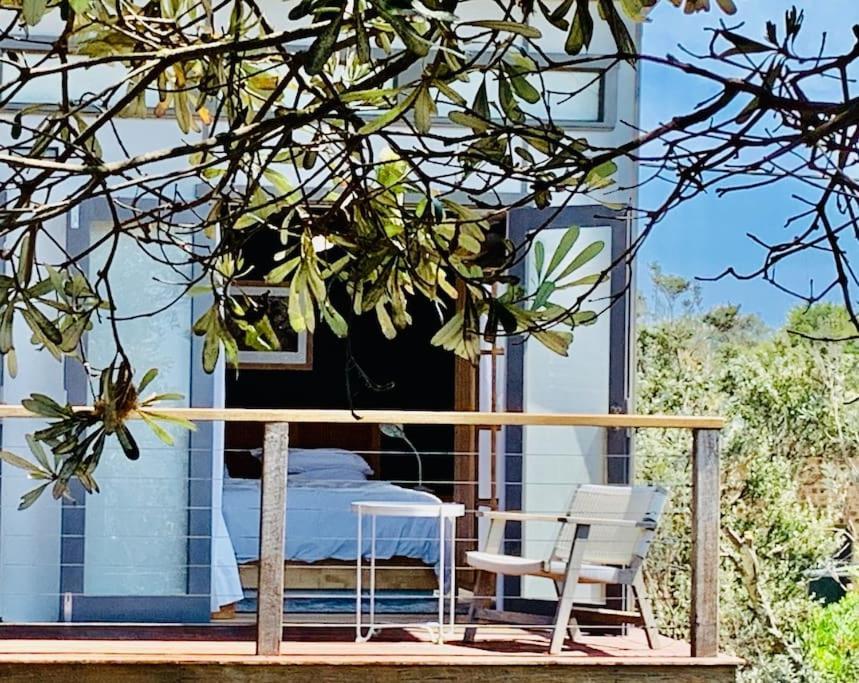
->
[639, 0, 859, 325]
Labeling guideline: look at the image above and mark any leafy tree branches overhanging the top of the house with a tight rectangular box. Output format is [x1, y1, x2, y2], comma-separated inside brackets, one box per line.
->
[0, 0, 859, 508]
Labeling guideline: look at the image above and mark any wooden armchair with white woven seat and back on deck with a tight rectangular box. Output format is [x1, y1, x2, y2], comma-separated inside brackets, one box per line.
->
[465, 484, 668, 654]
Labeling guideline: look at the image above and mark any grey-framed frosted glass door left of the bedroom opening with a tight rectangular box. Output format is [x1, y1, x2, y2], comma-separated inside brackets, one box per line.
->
[61, 195, 212, 622]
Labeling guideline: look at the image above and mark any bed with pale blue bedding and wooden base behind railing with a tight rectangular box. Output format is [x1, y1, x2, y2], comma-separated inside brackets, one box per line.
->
[215, 423, 439, 617]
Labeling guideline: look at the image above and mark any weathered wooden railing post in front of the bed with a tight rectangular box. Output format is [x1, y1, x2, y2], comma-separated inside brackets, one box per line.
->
[256, 422, 289, 655]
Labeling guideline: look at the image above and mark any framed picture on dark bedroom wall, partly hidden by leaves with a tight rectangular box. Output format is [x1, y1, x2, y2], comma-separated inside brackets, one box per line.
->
[225, 282, 313, 370]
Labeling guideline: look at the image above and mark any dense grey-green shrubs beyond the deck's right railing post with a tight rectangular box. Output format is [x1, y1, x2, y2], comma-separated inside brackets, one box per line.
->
[636, 271, 859, 683]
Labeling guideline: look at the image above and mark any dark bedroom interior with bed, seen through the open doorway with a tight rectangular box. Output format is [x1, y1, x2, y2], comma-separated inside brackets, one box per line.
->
[213, 222, 478, 619]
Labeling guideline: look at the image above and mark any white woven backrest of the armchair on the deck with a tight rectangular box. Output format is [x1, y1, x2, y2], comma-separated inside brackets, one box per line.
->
[551, 484, 668, 567]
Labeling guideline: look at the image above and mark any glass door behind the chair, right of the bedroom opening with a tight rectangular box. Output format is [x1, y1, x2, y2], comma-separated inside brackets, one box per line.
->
[505, 206, 628, 602]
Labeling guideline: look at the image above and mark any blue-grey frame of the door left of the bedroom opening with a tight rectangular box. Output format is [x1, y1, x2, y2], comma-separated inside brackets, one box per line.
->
[59, 198, 215, 623]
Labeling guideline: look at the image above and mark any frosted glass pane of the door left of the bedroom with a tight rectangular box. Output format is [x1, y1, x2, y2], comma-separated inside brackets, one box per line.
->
[84, 222, 191, 595]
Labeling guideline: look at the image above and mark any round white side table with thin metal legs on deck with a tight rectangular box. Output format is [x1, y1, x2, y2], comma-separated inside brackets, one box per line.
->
[352, 501, 465, 643]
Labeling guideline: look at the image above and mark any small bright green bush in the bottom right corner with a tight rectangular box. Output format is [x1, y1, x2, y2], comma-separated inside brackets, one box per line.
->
[801, 591, 859, 683]
